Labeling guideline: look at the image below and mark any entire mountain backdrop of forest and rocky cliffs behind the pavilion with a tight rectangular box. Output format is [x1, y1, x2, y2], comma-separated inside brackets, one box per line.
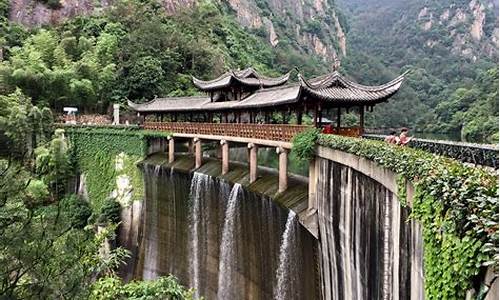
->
[0, 0, 498, 142]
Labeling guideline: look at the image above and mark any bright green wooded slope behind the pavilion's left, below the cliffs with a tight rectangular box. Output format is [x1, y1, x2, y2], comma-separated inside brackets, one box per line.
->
[0, 1, 342, 112]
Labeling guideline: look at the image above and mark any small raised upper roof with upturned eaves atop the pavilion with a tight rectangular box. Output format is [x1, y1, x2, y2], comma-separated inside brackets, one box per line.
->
[193, 68, 290, 91]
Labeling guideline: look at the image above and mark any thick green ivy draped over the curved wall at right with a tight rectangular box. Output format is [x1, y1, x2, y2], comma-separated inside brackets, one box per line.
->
[318, 135, 498, 299]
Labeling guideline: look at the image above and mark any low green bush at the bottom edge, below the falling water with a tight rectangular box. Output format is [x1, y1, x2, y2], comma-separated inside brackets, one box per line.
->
[90, 275, 194, 300]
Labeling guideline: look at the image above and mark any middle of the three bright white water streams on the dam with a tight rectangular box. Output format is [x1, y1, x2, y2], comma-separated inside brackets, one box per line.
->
[217, 183, 242, 299]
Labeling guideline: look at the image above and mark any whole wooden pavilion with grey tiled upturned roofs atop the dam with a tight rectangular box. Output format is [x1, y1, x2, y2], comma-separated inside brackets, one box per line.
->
[128, 68, 406, 136]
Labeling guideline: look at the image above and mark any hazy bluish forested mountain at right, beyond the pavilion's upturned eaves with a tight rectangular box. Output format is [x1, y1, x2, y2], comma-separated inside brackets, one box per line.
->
[340, 0, 498, 142]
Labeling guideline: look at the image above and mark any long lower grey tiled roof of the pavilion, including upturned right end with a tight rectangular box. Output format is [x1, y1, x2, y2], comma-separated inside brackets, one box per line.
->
[128, 69, 407, 113]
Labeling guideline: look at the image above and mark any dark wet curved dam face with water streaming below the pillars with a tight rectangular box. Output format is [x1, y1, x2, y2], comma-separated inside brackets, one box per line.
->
[133, 155, 317, 300]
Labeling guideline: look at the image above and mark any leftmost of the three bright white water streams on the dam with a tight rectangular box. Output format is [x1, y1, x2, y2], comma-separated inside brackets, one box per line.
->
[189, 172, 209, 298]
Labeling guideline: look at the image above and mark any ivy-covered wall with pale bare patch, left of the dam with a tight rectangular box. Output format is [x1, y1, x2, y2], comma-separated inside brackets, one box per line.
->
[65, 126, 168, 212]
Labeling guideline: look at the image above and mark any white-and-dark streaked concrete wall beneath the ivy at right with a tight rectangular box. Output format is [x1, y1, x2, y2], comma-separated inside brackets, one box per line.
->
[316, 147, 424, 299]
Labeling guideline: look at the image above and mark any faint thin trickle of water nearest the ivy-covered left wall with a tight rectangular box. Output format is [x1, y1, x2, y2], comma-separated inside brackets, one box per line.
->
[142, 165, 161, 280]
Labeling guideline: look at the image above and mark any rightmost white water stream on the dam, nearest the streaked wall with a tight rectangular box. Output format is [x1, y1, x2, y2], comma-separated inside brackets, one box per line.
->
[273, 210, 296, 300]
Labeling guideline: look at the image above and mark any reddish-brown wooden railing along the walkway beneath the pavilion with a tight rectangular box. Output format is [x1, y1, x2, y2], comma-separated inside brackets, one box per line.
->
[144, 122, 311, 142]
